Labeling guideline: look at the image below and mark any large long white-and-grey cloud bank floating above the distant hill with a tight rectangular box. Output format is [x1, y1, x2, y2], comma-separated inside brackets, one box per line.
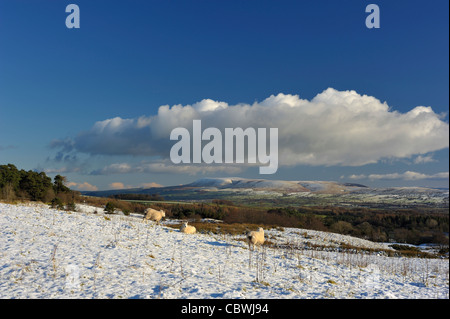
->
[52, 88, 449, 173]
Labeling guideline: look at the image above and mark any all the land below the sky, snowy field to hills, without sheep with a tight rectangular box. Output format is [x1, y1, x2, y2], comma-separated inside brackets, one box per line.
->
[0, 165, 449, 299]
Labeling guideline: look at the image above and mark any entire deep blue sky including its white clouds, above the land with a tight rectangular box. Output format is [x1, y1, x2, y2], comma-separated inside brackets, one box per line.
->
[0, 0, 449, 190]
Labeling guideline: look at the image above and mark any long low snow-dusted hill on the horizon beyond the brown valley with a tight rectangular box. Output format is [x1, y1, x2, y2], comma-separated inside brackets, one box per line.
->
[82, 177, 449, 208]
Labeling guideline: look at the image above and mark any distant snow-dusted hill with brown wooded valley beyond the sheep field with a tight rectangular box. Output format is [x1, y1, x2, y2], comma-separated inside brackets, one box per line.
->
[84, 178, 448, 245]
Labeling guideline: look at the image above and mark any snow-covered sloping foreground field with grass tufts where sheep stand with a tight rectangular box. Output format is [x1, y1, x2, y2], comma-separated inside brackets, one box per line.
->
[0, 203, 449, 299]
